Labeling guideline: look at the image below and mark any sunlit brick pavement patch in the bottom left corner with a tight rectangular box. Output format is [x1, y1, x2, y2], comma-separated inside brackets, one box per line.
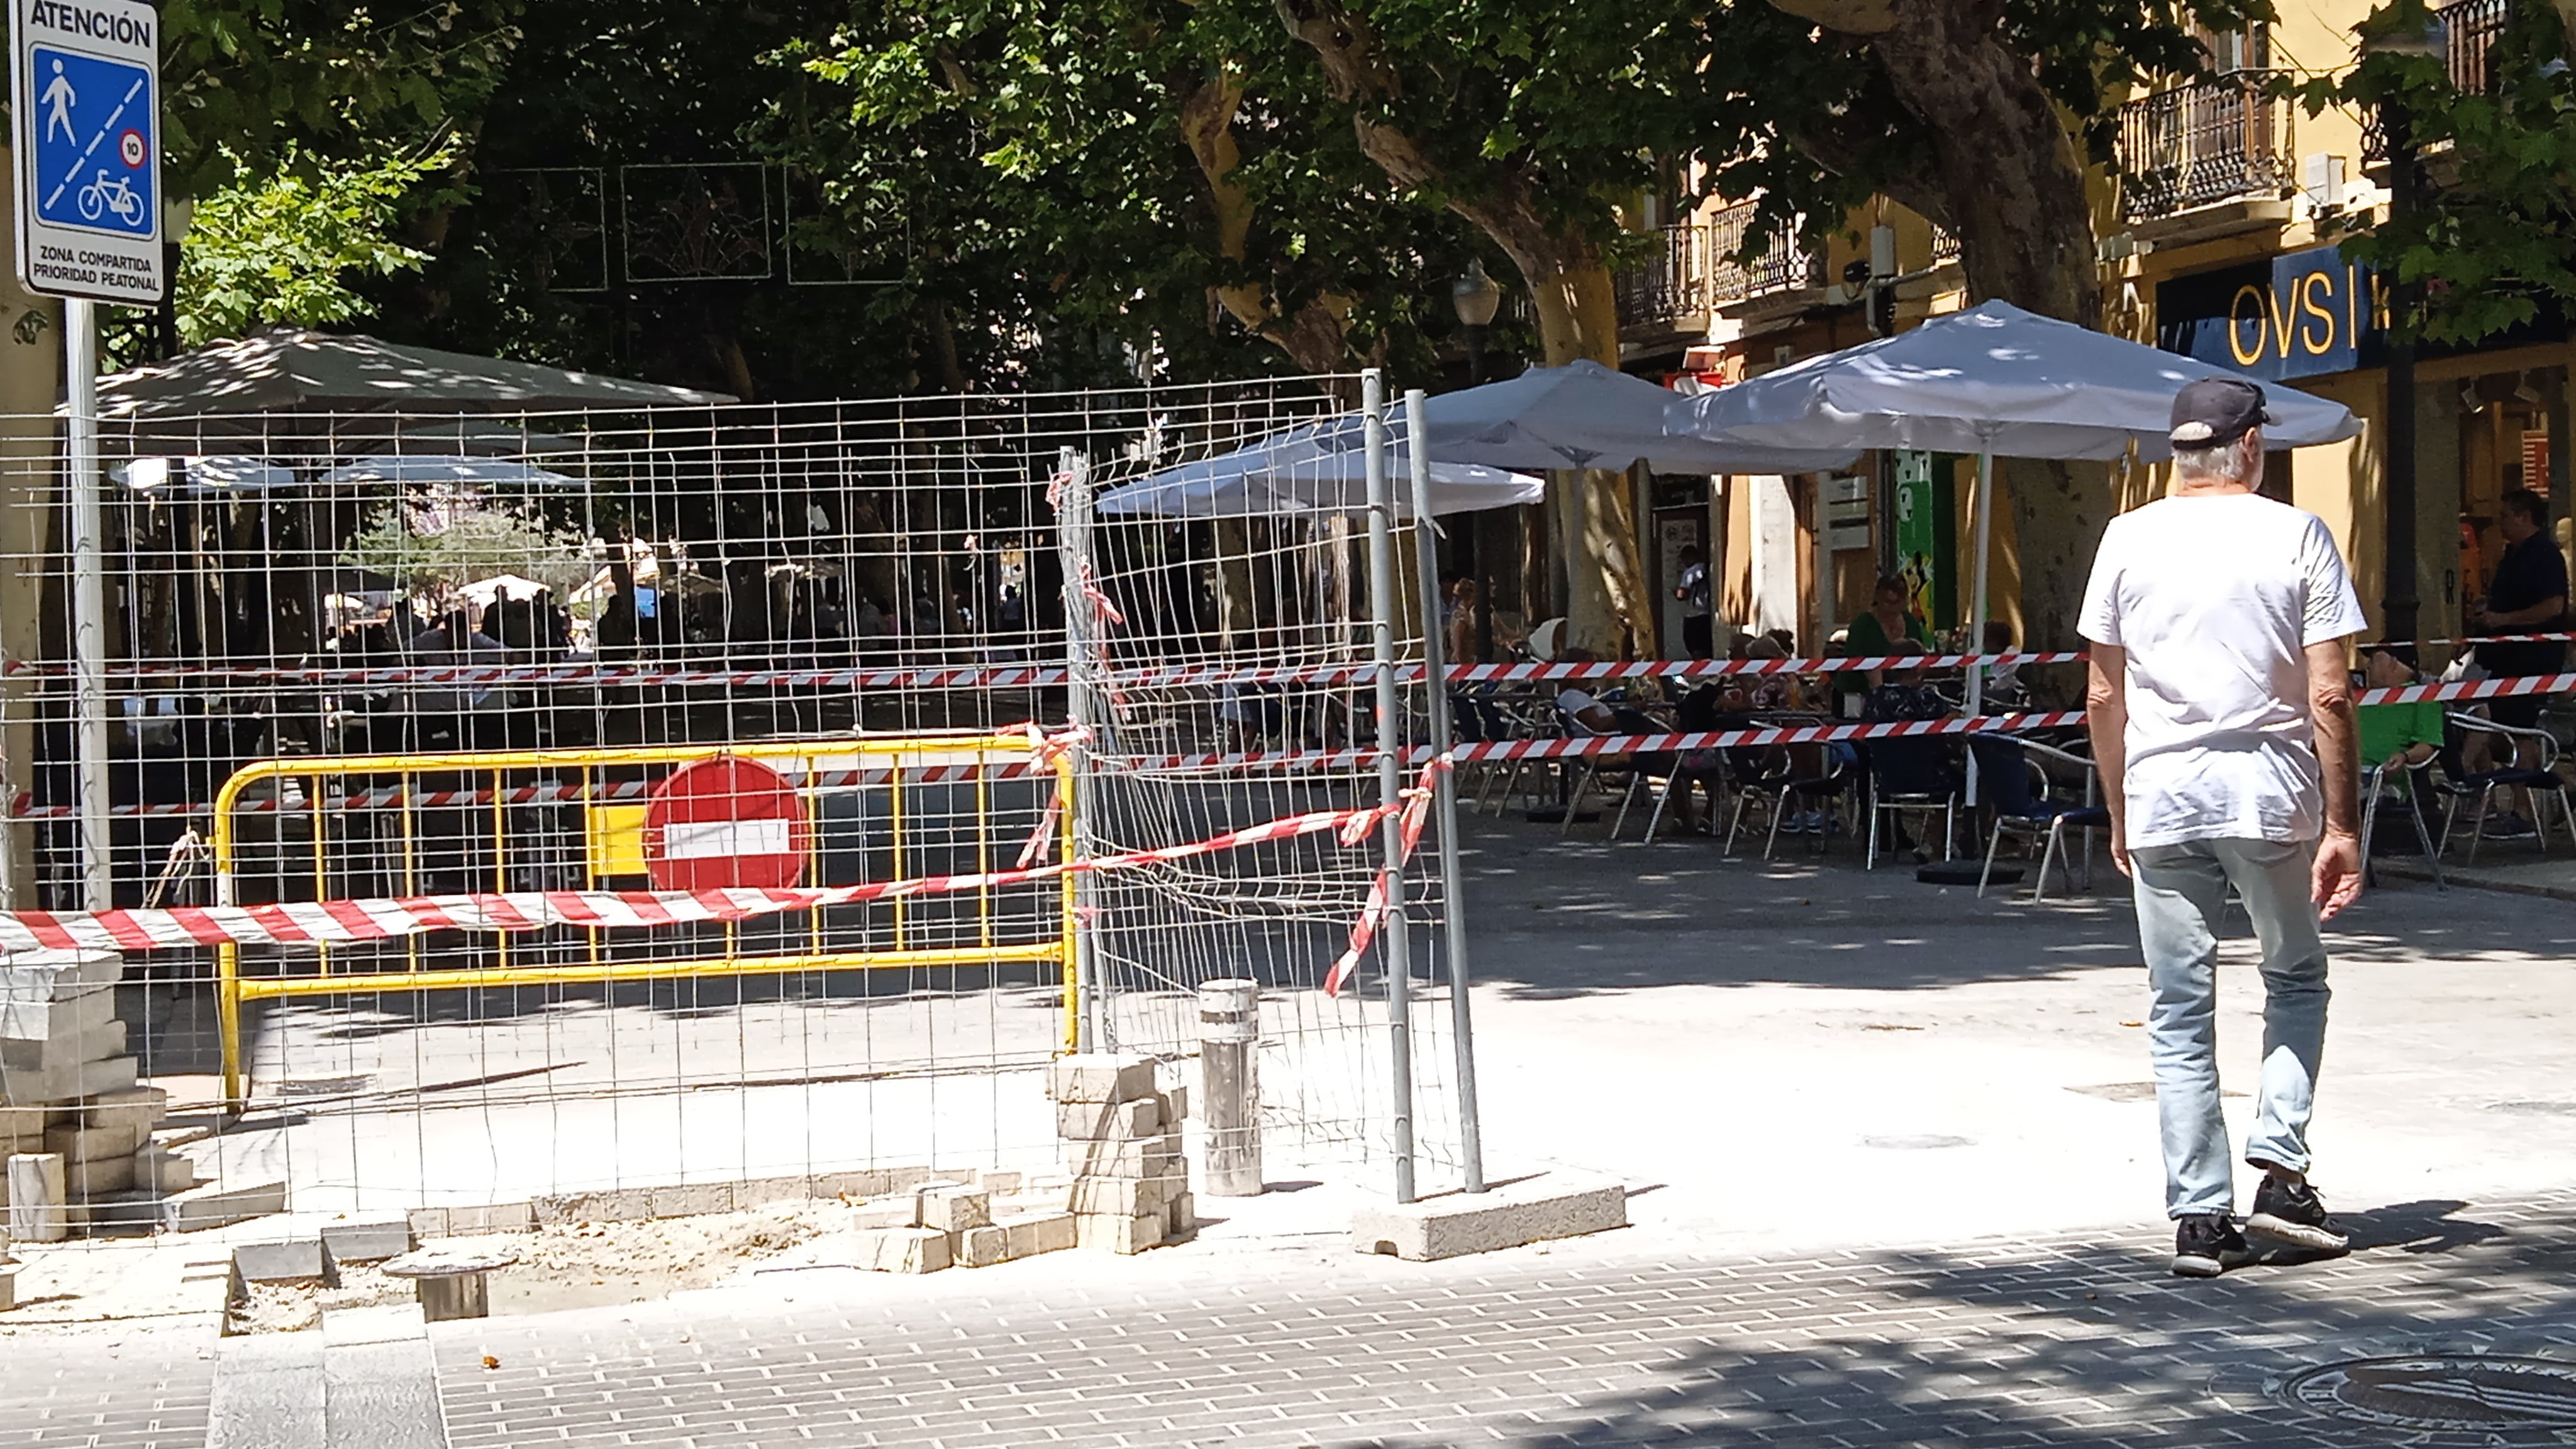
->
[0, 1315, 214, 1449]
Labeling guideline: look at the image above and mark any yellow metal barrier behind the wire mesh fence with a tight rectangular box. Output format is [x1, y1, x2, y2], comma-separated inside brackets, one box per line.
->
[214, 732, 1082, 1106]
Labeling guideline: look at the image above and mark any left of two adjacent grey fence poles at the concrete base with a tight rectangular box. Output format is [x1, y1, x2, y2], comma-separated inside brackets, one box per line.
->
[1360, 369, 1419, 1201]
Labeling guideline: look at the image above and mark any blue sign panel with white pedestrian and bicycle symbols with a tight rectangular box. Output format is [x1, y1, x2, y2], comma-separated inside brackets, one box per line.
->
[23, 44, 160, 237]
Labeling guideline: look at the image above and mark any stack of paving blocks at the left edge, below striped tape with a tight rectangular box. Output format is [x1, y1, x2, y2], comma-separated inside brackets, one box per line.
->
[0, 952, 196, 1227]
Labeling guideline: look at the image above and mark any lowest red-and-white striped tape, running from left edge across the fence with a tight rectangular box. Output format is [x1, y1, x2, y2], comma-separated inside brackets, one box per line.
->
[0, 776, 1427, 952]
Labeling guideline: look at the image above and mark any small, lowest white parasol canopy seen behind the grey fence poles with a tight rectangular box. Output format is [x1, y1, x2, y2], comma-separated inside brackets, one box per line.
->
[1095, 415, 1548, 518]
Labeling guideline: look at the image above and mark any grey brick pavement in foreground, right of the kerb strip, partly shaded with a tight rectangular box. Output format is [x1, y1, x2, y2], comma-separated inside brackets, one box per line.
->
[433, 1181, 2576, 1449]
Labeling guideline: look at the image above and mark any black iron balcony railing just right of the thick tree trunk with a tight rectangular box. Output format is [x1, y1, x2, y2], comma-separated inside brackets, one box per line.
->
[2120, 70, 2298, 222]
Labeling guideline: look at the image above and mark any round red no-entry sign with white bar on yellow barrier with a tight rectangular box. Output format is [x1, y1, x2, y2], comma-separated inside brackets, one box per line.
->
[644, 755, 814, 889]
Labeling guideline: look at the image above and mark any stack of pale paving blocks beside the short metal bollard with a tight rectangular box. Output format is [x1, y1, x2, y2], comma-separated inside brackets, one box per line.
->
[1046, 1052, 1198, 1253]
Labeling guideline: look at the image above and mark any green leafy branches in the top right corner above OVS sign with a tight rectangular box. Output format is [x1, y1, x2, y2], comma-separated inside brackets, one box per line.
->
[2298, 0, 2576, 343]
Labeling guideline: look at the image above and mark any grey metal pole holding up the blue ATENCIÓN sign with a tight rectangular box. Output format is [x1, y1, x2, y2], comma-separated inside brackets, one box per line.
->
[62, 299, 116, 910]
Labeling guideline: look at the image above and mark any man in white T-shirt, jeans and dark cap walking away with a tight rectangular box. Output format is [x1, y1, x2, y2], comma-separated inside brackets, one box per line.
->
[2079, 379, 2365, 1276]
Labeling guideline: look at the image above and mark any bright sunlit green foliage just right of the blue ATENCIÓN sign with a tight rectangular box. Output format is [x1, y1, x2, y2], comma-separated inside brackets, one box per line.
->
[178, 145, 456, 348]
